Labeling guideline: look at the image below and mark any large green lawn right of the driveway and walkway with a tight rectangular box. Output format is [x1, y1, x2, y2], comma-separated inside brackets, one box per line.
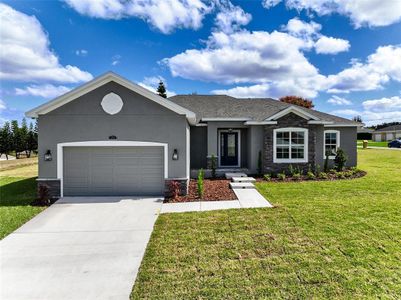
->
[131, 149, 401, 299]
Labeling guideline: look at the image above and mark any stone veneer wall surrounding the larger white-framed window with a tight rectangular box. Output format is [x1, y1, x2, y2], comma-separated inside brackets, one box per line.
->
[262, 113, 321, 173]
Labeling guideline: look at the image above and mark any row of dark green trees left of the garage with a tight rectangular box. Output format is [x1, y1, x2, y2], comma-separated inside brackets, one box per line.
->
[0, 118, 38, 159]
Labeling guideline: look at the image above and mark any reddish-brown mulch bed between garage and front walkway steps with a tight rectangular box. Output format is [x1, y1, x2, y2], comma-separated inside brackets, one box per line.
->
[164, 179, 237, 203]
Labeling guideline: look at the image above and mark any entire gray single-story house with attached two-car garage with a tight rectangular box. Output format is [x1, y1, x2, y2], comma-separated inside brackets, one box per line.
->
[26, 73, 361, 196]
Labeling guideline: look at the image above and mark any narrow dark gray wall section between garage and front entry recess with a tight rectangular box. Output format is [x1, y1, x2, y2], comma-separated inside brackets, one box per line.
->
[190, 126, 207, 169]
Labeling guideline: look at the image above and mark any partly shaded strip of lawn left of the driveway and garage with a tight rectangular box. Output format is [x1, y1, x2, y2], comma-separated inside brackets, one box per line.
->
[0, 159, 44, 239]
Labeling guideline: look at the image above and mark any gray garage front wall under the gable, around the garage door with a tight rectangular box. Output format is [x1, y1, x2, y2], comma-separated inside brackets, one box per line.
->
[38, 82, 187, 178]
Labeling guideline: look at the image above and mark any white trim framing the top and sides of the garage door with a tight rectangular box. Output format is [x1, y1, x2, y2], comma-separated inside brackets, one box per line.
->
[57, 141, 168, 197]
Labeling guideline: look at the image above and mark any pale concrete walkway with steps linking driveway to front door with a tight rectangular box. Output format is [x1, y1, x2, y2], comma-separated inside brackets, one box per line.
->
[160, 173, 273, 214]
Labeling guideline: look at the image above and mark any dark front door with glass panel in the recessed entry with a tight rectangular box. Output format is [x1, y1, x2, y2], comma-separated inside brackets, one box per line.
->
[220, 132, 239, 167]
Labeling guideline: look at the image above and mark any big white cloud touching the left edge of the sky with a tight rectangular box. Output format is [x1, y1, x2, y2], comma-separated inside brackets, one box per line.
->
[0, 3, 92, 83]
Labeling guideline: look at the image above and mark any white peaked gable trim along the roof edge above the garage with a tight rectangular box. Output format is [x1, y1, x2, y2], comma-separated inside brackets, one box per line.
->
[25, 72, 196, 125]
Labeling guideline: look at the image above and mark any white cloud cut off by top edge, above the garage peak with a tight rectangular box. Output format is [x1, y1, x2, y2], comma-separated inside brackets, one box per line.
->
[65, 0, 214, 33]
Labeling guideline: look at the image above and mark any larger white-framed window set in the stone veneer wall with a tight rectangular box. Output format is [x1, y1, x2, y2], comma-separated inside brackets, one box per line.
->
[273, 128, 308, 163]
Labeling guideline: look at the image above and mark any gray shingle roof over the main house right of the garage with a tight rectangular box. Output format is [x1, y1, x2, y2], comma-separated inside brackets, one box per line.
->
[169, 95, 362, 125]
